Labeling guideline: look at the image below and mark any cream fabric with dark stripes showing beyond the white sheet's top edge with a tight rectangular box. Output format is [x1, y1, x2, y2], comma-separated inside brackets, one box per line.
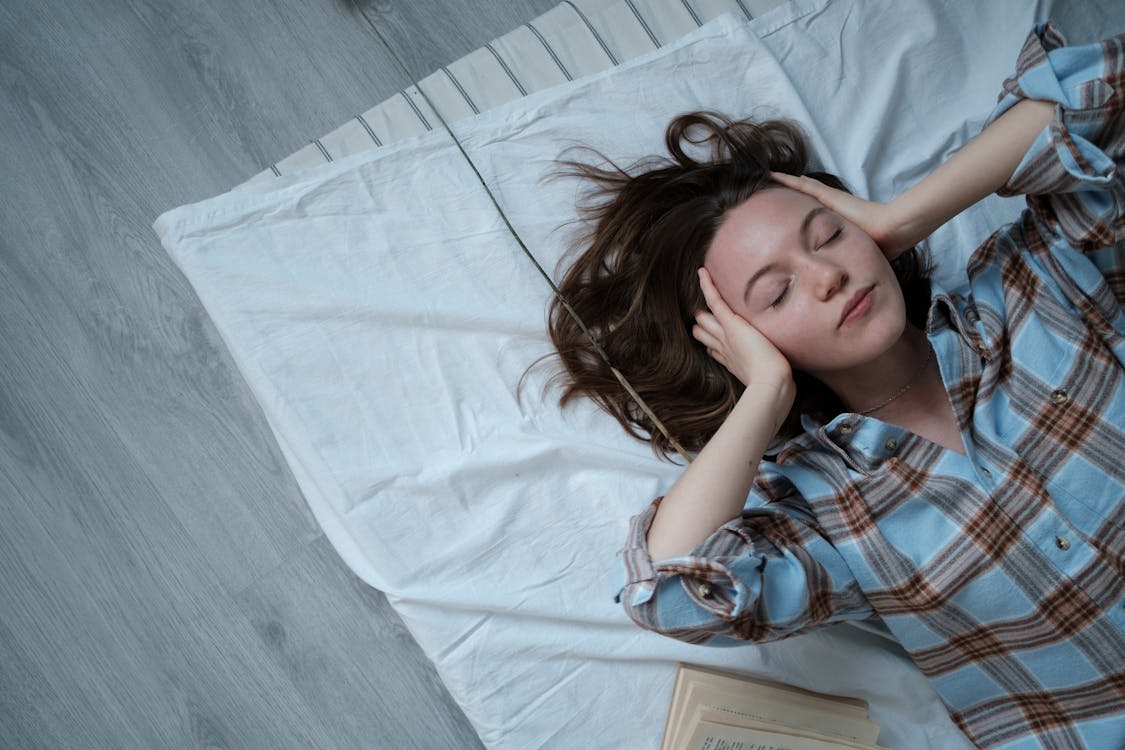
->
[239, 0, 785, 187]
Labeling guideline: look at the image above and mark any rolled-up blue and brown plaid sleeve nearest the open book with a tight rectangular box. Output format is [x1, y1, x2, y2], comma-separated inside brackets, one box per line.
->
[618, 488, 873, 645]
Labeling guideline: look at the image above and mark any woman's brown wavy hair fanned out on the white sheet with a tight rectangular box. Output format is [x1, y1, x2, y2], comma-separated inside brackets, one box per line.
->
[549, 111, 929, 454]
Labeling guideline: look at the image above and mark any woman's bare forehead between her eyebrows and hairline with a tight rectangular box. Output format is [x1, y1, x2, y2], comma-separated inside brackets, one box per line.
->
[707, 187, 821, 265]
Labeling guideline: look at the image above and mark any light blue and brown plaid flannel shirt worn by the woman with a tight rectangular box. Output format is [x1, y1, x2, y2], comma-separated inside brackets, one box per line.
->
[619, 26, 1125, 749]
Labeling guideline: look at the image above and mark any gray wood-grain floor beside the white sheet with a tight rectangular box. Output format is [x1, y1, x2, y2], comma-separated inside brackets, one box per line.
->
[0, 0, 557, 749]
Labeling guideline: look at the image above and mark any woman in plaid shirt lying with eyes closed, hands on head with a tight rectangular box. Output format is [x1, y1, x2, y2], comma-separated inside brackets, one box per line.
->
[551, 27, 1125, 748]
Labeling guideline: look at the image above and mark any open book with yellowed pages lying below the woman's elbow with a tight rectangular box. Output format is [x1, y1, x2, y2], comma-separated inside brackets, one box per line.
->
[660, 665, 882, 750]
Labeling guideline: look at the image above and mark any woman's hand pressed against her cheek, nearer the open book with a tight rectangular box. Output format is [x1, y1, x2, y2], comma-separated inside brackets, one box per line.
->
[692, 269, 797, 412]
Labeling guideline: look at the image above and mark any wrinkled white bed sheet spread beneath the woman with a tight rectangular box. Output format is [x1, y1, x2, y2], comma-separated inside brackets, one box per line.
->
[155, 0, 1121, 750]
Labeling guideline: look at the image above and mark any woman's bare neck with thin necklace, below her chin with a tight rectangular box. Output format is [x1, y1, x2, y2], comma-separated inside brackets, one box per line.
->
[817, 324, 939, 418]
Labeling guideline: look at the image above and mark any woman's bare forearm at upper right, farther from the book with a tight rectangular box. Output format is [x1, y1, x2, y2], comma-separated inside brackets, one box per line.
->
[888, 99, 1055, 258]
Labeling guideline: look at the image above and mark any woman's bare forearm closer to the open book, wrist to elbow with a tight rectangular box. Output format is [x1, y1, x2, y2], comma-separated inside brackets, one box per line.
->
[648, 383, 792, 560]
